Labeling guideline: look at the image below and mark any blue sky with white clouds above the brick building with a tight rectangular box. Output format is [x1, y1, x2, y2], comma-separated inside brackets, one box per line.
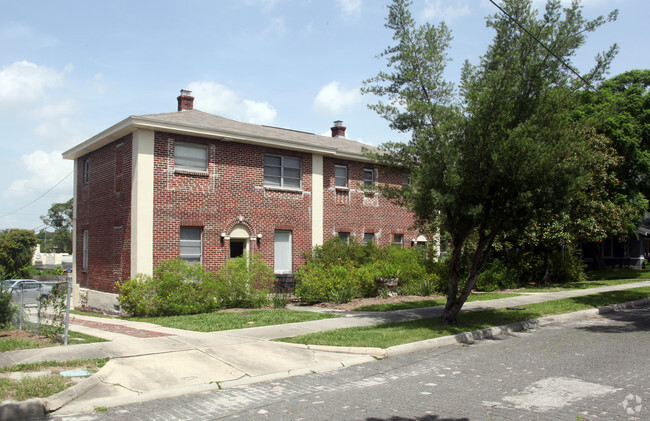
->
[0, 0, 650, 229]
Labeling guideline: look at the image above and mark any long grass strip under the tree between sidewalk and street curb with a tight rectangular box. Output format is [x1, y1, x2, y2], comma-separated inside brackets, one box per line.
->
[279, 287, 650, 348]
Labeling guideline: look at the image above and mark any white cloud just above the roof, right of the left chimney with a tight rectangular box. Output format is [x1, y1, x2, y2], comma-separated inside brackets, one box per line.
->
[187, 81, 277, 124]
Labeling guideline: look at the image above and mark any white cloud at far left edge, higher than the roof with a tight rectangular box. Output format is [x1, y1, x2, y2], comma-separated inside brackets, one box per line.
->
[0, 61, 66, 105]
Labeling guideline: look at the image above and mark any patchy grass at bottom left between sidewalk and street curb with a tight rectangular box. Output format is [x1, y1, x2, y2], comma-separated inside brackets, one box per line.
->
[0, 358, 108, 401]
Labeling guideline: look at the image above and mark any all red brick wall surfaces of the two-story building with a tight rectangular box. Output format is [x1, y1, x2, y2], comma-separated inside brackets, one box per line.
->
[77, 132, 417, 292]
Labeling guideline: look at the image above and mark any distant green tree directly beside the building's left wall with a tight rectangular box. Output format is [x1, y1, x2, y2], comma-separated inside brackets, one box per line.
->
[37, 199, 72, 253]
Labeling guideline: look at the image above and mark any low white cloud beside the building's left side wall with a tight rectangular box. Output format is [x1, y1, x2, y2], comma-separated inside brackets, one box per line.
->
[2, 150, 72, 199]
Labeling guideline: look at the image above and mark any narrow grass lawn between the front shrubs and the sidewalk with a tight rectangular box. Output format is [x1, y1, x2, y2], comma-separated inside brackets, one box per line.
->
[128, 309, 339, 332]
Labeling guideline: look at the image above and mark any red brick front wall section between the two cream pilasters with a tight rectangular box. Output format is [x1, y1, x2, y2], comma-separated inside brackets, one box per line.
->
[154, 132, 312, 271]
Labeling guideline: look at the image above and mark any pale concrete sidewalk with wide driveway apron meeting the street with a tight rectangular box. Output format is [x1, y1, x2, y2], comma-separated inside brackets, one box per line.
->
[0, 281, 650, 419]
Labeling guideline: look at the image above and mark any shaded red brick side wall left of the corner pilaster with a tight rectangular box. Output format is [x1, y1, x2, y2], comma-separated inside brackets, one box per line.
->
[76, 135, 133, 292]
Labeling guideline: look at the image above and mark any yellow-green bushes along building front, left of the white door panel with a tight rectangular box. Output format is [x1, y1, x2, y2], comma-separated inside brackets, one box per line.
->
[115, 255, 275, 317]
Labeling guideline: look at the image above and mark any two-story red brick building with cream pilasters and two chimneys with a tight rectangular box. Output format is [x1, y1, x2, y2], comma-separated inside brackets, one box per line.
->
[63, 91, 426, 309]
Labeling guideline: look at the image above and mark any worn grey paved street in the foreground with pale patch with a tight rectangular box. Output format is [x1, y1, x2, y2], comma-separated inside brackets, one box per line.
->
[49, 306, 650, 421]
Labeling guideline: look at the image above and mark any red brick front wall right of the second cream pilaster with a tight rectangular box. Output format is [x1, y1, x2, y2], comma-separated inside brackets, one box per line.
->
[323, 157, 417, 246]
